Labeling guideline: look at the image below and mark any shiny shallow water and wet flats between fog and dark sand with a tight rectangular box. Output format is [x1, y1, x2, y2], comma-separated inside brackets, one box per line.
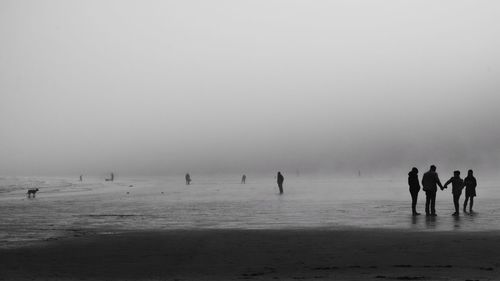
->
[0, 175, 500, 248]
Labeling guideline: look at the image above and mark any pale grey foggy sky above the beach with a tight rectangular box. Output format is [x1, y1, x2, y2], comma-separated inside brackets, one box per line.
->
[0, 0, 500, 175]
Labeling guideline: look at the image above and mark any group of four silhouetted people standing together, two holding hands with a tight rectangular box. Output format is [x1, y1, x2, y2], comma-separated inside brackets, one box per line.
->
[408, 165, 477, 216]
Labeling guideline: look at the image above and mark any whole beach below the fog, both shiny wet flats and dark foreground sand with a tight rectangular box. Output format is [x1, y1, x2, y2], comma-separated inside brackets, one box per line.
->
[0, 176, 500, 280]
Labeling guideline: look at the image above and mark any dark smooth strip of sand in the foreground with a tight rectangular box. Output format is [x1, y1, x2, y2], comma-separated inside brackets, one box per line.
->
[0, 229, 500, 280]
